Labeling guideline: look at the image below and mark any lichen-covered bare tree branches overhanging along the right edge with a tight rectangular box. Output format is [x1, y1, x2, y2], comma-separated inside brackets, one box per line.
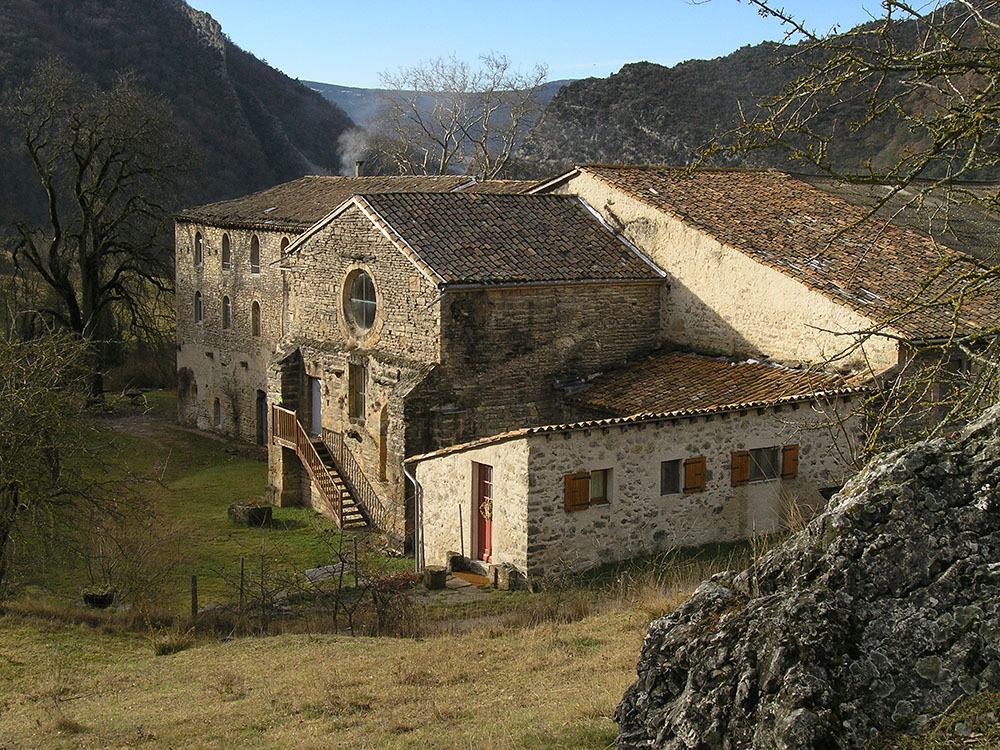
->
[713, 0, 1000, 449]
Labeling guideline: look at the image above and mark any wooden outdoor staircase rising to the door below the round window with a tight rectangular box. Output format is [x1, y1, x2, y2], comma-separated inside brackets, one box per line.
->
[271, 406, 376, 529]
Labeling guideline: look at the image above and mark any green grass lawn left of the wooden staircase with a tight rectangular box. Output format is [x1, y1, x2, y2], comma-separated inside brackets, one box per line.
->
[16, 392, 412, 612]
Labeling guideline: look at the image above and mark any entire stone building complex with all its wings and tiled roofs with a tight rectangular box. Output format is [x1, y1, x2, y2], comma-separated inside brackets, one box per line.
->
[177, 166, 996, 575]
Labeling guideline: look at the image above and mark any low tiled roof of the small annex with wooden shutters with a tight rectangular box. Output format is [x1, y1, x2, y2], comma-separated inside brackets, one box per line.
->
[570, 352, 851, 416]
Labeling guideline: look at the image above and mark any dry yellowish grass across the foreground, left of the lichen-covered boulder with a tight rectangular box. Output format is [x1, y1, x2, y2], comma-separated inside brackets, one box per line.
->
[0, 608, 660, 748]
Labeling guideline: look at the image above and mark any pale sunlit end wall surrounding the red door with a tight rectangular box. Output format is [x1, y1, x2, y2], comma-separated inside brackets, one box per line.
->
[416, 440, 528, 570]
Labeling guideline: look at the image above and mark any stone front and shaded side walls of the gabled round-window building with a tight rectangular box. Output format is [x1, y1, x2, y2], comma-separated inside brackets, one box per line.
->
[268, 207, 664, 548]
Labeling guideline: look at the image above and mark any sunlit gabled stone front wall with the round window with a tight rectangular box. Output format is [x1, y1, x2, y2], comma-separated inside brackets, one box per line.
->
[270, 208, 440, 538]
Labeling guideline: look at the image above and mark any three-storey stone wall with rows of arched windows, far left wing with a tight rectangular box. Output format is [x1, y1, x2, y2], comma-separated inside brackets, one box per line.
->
[175, 222, 295, 441]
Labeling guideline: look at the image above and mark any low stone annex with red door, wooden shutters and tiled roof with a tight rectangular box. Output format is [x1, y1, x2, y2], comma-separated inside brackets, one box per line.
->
[407, 352, 864, 578]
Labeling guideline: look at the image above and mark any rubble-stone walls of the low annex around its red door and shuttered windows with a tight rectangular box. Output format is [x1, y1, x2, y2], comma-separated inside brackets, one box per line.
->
[415, 398, 852, 577]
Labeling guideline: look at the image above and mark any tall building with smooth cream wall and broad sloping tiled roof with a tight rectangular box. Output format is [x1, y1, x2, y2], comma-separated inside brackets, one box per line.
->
[535, 165, 997, 374]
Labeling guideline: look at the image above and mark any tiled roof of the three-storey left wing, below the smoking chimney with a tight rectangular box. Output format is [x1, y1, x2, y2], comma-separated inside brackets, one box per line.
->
[177, 175, 471, 232]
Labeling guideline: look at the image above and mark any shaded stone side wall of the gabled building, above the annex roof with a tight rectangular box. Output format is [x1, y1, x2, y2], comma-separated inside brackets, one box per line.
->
[407, 282, 665, 455]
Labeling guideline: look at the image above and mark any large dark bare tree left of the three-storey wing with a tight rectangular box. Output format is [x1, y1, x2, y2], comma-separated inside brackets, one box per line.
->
[6, 61, 185, 397]
